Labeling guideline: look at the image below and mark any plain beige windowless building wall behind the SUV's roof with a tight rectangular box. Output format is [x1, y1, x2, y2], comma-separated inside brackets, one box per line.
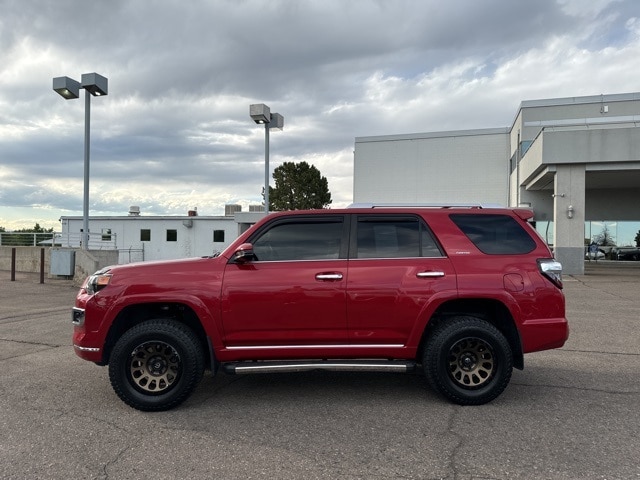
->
[353, 129, 509, 205]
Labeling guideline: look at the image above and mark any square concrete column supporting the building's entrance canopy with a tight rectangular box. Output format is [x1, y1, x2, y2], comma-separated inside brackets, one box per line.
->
[553, 164, 585, 275]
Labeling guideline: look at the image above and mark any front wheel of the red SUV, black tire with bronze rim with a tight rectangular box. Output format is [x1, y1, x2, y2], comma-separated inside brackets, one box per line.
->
[109, 319, 204, 411]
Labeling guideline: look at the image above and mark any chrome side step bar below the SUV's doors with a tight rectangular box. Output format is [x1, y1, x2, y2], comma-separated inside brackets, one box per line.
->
[222, 360, 416, 375]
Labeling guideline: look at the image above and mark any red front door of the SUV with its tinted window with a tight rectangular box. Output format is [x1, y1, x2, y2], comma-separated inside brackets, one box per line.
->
[222, 215, 348, 348]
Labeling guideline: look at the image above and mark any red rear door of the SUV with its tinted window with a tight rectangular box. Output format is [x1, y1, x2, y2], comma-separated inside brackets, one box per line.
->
[347, 214, 456, 346]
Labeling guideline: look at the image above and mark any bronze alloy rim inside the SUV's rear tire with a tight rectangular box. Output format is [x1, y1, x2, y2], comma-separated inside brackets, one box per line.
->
[449, 338, 495, 388]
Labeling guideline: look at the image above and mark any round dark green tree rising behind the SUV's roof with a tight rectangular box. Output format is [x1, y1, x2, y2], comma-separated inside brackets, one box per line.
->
[269, 162, 331, 211]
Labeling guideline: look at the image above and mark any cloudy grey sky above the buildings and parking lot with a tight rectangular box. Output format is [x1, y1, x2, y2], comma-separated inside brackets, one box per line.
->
[0, 0, 640, 230]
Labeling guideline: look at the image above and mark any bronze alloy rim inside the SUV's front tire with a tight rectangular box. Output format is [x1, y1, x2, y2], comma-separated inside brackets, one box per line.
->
[129, 340, 180, 394]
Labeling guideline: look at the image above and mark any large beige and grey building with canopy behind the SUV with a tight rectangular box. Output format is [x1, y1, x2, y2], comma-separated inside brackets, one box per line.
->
[354, 93, 640, 274]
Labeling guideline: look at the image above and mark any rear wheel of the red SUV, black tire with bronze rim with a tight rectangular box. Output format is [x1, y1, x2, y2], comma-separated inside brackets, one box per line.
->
[422, 316, 513, 405]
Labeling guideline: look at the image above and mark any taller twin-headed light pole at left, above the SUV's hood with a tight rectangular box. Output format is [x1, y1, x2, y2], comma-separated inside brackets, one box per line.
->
[53, 73, 108, 250]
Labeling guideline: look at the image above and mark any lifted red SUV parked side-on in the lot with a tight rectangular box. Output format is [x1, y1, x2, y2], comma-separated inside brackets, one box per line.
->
[73, 205, 569, 410]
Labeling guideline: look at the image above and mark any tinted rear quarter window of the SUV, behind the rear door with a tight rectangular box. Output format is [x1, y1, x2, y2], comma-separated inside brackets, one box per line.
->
[450, 213, 536, 255]
